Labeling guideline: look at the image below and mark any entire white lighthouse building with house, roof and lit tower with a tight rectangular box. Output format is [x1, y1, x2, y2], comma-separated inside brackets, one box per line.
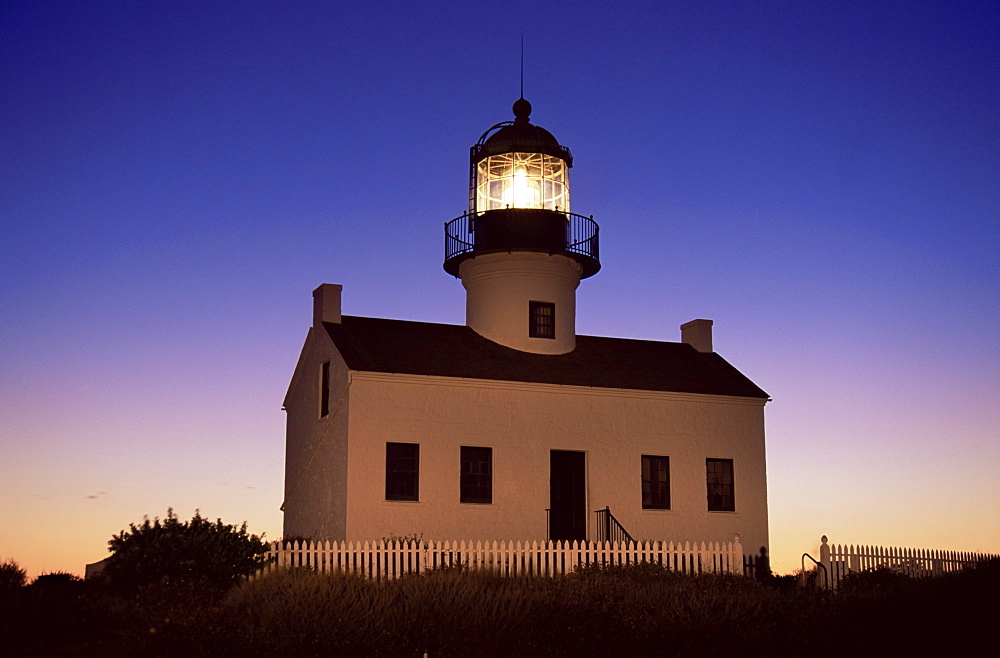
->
[282, 98, 769, 550]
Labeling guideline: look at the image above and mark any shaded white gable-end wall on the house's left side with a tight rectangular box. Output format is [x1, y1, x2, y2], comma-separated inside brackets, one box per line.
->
[283, 329, 350, 540]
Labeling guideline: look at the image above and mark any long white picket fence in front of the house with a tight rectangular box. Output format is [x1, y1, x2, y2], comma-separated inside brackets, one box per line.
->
[263, 535, 744, 578]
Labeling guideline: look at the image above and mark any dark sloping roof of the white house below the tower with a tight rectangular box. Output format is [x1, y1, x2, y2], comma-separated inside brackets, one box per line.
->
[324, 315, 768, 398]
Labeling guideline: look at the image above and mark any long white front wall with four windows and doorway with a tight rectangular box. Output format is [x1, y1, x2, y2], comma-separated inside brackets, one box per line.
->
[340, 372, 768, 553]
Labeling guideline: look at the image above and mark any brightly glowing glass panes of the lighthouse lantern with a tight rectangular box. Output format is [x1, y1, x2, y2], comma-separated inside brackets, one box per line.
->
[475, 153, 569, 212]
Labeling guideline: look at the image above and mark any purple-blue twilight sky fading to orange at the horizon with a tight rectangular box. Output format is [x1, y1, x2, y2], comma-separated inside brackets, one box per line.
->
[0, 1, 1000, 575]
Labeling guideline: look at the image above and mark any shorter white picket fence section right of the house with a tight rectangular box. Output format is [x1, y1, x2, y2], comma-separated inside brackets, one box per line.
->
[817, 535, 998, 589]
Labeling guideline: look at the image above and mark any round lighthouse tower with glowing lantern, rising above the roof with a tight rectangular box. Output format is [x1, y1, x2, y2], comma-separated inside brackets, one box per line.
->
[444, 98, 601, 354]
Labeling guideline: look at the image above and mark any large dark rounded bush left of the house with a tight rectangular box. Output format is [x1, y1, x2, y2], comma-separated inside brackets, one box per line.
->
[104, 509, 267, 590]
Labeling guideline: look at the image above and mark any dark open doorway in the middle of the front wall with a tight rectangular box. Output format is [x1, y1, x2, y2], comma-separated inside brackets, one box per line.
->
[549, 450, 587, 541]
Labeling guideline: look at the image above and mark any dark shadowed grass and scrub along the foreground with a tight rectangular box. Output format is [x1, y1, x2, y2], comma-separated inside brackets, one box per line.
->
[0, 561, 1000, 657]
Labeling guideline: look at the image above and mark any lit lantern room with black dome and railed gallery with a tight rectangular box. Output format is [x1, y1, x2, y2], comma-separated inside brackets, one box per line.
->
[444, 98, 601, 278]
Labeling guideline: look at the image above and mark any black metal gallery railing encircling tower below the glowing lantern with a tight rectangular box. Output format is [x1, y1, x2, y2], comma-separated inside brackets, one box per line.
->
[444, 209, 600, 277]
